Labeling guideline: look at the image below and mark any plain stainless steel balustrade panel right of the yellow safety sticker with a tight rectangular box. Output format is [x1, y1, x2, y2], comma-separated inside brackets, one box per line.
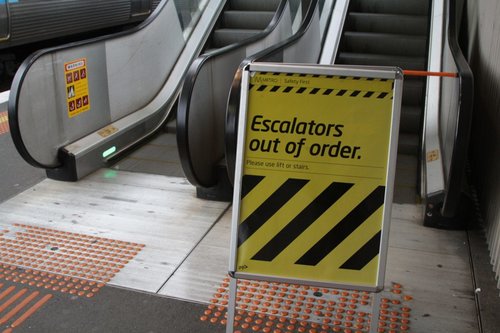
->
[106, 1, 185, 121]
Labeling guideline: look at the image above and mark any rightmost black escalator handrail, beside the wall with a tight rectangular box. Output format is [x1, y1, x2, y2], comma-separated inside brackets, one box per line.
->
[441, 0, 474, 217]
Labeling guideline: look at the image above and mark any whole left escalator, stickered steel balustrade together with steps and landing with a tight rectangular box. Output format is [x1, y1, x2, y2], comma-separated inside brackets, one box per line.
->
[9, 0, 291, 181]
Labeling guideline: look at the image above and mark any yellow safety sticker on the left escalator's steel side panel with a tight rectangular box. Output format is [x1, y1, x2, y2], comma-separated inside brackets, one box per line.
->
[64, 58, 90, 118]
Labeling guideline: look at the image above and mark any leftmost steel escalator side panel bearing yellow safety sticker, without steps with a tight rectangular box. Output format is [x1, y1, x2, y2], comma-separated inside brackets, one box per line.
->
[9, 0, 225, 180]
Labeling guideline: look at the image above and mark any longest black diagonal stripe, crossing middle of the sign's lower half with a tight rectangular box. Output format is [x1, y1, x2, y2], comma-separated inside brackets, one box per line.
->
[252, 182, 353, 261]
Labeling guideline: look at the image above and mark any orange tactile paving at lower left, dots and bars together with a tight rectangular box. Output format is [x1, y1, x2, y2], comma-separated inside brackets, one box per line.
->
[0, 224, 144, 333]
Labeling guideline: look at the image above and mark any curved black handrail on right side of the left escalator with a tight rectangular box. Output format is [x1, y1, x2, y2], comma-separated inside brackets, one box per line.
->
[177, 0, 288, 186]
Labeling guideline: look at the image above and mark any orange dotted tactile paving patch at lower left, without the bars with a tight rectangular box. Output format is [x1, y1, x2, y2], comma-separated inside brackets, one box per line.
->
[0, 224, 144, 297]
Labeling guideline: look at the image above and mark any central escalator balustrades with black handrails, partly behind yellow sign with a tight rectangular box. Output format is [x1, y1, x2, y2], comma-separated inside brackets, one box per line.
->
[177, 0, 335, 201]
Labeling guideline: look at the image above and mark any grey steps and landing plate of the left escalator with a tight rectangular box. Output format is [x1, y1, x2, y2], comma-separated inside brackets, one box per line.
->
[110, 0, 289, 177]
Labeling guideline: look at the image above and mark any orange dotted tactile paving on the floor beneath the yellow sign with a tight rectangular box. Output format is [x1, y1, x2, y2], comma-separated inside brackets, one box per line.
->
[200, 278, 413, 333]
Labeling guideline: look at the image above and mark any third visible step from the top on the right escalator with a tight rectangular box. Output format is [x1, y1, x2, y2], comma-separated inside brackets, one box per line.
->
[341, 31, 427, 57]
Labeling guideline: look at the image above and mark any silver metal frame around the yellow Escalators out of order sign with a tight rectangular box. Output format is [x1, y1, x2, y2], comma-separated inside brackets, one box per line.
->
[228, 63, 403, 330]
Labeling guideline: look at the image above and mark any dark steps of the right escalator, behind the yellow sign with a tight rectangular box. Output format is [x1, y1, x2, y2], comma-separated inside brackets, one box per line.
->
[335, 0, 430, 203]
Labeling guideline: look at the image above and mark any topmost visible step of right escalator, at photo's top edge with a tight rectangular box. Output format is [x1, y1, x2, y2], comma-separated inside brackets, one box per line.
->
[351, 0, 429, 15]
